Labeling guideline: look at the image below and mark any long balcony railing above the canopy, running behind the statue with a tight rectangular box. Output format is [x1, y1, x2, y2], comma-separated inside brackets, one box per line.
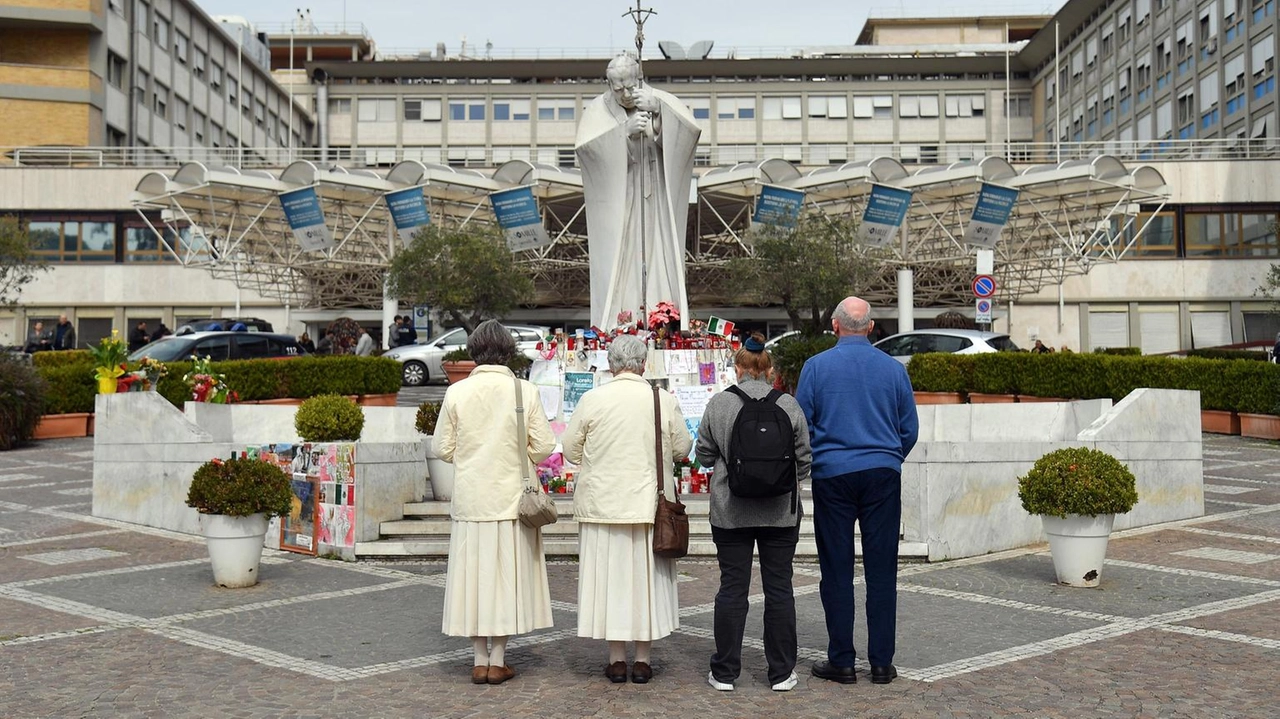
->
[0, 138, 1280, 169]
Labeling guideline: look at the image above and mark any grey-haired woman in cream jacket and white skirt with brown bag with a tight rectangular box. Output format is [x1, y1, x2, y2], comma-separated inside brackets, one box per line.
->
[563, 335, 692, 684]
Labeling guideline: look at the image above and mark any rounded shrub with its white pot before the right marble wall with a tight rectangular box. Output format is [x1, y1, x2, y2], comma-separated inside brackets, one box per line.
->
[1018, 446, 1138, 587]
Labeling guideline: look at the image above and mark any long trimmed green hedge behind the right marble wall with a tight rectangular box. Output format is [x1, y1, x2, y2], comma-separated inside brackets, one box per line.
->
[906, 352, 1280, 415]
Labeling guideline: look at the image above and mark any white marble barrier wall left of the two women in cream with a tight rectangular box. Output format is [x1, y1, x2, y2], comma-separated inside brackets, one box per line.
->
[93, 391, 428, 558]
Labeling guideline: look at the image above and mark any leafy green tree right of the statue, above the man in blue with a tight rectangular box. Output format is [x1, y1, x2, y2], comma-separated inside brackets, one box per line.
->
[728, 212, 881, 334]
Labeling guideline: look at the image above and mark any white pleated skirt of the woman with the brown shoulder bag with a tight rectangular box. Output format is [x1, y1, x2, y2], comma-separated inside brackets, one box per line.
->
[577, 522, 680, 641]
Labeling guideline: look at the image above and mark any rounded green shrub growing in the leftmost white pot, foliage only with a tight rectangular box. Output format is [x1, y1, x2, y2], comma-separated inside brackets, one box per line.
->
[187, 459, 293, 517]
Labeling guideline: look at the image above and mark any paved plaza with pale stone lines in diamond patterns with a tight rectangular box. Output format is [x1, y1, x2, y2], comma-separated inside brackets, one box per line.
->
[0, 435, 1280, 719]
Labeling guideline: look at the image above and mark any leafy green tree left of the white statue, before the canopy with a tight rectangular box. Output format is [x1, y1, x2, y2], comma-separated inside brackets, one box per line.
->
[387, 224, 534, 333]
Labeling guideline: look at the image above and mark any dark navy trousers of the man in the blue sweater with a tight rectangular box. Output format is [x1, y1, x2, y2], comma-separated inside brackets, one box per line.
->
[813, 468, 902, 667]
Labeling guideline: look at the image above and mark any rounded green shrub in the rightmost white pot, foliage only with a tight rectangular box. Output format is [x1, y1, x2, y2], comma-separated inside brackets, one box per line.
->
[1018, 446, 1138, 517]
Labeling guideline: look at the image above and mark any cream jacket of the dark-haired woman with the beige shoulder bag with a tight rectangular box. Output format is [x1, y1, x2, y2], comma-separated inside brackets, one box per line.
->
[433, 365, 556, 522]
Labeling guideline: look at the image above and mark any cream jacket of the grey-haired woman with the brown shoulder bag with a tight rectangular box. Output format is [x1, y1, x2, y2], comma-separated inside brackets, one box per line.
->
[562, 372, 692, 525]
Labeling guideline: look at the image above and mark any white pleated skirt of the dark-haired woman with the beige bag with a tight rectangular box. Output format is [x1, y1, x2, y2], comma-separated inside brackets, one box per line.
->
[442, 519, 552, 637]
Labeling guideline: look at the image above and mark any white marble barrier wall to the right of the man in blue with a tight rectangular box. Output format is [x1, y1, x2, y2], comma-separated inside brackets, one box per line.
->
[902, 389, 1204, 562]
